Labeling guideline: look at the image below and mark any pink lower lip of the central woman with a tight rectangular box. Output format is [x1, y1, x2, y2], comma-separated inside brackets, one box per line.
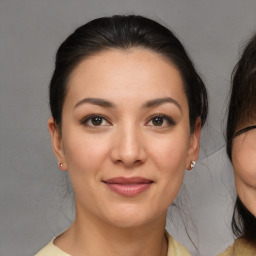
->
[106, 183, 152, 196]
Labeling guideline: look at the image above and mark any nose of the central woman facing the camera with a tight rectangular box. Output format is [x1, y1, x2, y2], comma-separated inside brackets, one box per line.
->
[111, 126, 146, 168]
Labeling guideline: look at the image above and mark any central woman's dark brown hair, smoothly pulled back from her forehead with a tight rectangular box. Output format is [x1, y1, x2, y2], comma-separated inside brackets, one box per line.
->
[50, 15, 208, 131]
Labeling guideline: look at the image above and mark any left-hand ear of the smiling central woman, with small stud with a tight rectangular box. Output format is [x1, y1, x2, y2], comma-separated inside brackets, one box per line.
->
[48, 117, 67, 171]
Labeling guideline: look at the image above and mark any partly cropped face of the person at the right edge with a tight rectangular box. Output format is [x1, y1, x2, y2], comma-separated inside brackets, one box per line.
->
[232, 124, 256, 217]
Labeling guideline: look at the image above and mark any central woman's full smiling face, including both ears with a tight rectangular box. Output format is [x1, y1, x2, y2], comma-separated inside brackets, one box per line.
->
[49, 49, 200, 227]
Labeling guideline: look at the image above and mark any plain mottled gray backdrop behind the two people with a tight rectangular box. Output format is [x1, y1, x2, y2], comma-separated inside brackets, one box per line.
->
[0, 0, 256, 256]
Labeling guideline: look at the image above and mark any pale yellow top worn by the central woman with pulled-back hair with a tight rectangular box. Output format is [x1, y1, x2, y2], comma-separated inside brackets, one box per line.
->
[35, 233, 191, 256]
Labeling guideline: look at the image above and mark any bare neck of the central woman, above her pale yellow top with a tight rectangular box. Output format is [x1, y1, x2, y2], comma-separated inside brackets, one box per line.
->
[54, 203, 168, 256]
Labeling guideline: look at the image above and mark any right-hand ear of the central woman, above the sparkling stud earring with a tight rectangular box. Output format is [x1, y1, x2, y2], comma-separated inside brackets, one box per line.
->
[186, 118, 201, 170]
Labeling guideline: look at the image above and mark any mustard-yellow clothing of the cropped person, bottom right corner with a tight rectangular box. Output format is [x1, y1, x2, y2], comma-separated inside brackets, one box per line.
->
[218, 238, 256, 256]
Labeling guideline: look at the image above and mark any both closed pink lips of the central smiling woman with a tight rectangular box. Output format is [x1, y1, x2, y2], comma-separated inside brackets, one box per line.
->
[103, 177, 153, 197]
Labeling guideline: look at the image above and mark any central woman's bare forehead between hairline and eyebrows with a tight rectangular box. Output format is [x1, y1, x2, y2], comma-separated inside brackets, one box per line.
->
[67, 48, 187, 105]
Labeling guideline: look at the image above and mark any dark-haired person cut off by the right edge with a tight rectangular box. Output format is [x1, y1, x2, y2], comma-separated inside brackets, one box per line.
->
[220, 34, 256, 256]
